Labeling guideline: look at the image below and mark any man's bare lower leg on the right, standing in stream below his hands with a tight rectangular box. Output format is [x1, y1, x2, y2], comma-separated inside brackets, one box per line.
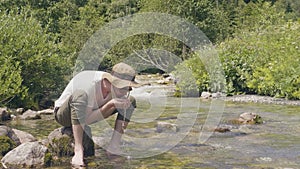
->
[107, 120, 128, 155]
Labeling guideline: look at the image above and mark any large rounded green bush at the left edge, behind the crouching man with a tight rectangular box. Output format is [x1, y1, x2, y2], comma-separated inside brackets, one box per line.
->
[0, 7, 70, 109]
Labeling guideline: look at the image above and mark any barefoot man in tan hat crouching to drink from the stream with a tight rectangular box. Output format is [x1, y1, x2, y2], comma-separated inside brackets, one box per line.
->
[54, 63, 143, 167]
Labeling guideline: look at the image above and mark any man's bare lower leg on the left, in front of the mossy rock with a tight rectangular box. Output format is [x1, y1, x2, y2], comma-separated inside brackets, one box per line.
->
[71, 124, 84, 165]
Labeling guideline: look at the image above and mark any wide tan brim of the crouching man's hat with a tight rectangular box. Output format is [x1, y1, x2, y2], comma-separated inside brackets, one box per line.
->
[103, 73, 149, 88]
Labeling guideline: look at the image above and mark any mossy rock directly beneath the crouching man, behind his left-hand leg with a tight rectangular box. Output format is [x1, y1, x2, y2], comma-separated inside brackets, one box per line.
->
[48, 126, 95, 156]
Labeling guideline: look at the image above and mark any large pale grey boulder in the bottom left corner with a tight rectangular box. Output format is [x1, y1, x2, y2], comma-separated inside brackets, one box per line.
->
[1, 142, 47, 168]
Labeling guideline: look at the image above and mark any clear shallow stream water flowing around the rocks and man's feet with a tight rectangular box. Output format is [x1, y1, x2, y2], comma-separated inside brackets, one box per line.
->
[4, 88, 300, 169]
